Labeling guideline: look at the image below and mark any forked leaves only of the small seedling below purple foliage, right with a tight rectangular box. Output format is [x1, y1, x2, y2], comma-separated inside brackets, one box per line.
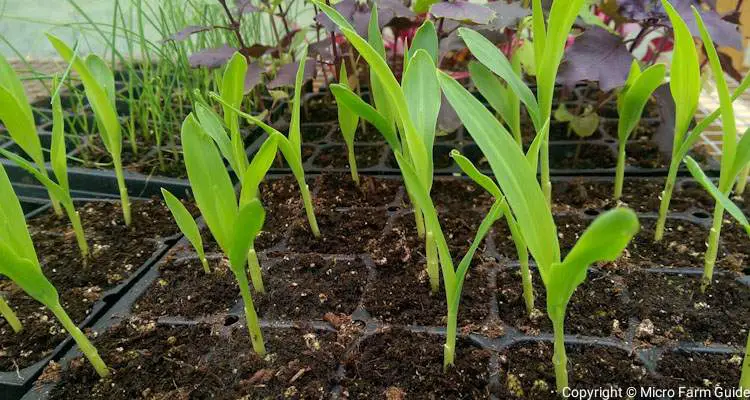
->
[617, 61, 667, 142]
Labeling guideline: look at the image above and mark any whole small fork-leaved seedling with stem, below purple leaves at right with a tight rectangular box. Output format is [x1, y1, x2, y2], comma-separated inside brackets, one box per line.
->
[615, 60, 667, 200]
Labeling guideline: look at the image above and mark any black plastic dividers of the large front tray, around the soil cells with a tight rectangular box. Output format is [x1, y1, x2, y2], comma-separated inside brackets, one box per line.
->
[19, 177, 750, 399]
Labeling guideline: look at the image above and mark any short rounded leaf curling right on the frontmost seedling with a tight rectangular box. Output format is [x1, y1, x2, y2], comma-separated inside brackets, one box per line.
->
[545, 208, 640, 309]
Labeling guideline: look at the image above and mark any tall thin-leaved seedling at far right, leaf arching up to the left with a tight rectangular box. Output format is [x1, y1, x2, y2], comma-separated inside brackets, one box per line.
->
[693, 8, 750, 289]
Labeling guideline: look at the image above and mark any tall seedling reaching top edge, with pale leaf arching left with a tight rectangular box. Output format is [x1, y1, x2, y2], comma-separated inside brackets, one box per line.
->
[459, 0, 584, 203]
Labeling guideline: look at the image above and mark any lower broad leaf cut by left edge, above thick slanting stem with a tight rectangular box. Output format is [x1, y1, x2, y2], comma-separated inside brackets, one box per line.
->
[0, 164, 37, 262]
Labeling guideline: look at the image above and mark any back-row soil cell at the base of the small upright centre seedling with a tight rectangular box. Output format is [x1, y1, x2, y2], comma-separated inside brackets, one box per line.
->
[314, 173, 401, 210]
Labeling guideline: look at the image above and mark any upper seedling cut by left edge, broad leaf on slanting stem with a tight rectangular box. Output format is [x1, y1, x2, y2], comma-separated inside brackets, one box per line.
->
[0, 55, 62, 215]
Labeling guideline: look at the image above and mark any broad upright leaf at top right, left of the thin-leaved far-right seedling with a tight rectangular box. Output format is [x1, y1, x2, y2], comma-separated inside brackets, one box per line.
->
[662, 0, 701, 143]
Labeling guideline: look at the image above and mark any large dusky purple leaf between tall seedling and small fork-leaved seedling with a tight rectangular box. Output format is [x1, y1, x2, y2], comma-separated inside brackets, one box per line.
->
[558, 27, 633, 92]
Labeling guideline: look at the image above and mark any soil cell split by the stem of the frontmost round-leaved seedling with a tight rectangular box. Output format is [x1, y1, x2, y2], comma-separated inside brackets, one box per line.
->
[496, 269, 628, 338]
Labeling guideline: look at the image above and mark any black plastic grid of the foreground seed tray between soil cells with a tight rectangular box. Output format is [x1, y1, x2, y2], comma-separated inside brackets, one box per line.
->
[23, 178, 750, 400]
